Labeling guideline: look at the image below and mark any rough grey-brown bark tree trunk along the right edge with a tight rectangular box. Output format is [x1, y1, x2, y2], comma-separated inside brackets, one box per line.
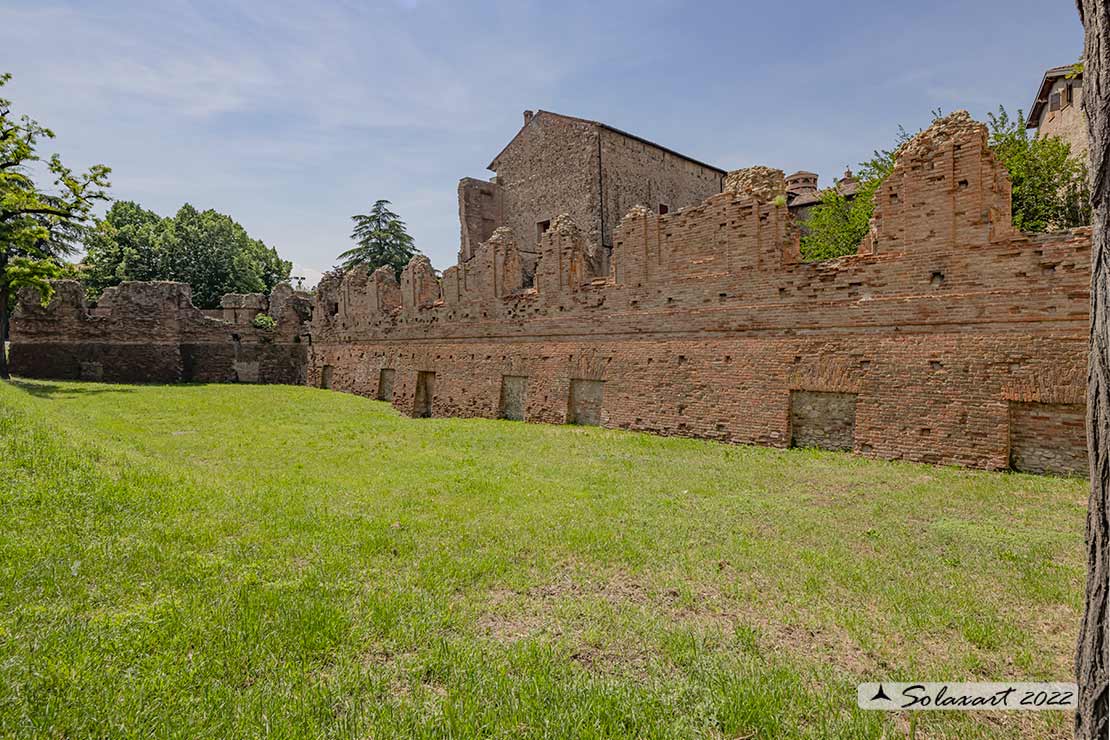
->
[1076, 0, 1110, 740]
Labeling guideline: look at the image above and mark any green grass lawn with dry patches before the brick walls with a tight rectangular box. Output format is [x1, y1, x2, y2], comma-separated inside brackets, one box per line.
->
[0, 382, 1087, 739]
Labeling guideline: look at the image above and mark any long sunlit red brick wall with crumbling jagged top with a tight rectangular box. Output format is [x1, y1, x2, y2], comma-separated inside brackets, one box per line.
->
[309, 113, 1090, 473]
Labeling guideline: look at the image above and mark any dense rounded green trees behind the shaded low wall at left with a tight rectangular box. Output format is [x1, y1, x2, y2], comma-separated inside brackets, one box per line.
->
[81, 201, 293, 308]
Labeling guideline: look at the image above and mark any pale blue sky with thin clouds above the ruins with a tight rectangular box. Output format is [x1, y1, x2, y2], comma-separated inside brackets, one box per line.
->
[0, 0, 1082, 282]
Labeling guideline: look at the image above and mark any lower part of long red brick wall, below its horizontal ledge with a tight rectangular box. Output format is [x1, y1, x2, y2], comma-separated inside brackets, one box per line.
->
[314, 333, 1087, 474]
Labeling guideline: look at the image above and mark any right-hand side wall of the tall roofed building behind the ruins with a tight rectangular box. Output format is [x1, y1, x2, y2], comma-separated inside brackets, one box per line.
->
[601, 129, 722, 246]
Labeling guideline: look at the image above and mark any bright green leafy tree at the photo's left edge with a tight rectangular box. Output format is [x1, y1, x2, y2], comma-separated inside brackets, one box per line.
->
[0, 74, 110, 378]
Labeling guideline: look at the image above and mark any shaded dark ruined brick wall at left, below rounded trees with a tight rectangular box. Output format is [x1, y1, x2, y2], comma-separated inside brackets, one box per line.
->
[10, 281, 311, 384]
